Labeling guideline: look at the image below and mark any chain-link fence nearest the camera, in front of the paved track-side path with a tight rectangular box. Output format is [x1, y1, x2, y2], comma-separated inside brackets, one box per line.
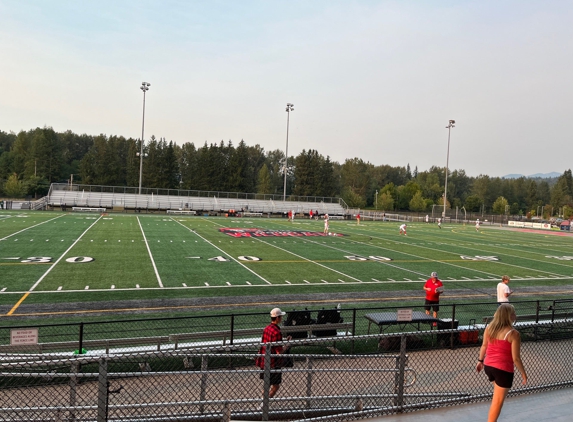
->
[0, 328, 573, 422]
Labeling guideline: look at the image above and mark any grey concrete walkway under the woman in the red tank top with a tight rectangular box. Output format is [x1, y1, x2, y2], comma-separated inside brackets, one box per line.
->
[363, 388, 573, 422]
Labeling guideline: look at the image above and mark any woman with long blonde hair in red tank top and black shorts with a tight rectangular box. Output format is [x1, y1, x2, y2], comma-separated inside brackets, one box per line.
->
[476, 303, 527, 422]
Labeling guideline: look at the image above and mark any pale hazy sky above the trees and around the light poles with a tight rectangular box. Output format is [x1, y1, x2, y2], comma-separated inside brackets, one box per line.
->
[0, 0, 573, 176]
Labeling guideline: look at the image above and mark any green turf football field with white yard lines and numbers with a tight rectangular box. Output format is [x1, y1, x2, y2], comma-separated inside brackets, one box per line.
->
[0, 211, 573, 315]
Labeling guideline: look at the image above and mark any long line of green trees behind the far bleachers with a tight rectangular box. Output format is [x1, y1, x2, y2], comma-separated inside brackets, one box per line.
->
[0, 127, 573, 217]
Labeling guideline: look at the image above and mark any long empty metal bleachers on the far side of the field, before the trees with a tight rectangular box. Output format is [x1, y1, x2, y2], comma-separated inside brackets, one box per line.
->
[47, 183, 346, 216]
